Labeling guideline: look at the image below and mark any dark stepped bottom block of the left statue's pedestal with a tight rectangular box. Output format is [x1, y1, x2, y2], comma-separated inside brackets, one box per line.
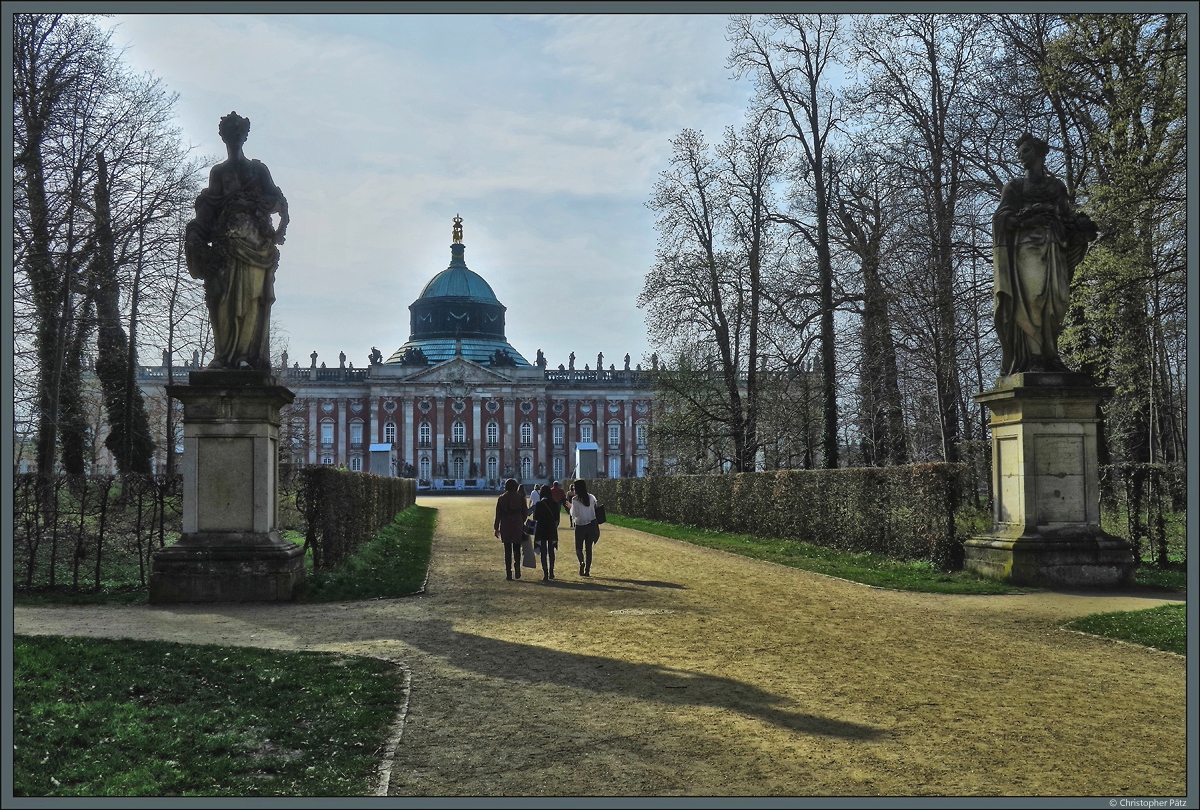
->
[150, 532, 304, 602]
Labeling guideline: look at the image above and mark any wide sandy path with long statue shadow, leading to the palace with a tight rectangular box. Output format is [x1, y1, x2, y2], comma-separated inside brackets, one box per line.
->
[16, 497, 1186, 796]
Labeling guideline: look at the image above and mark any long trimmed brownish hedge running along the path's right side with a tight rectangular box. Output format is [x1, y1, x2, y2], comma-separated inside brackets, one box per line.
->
[588, 463, 972, 570]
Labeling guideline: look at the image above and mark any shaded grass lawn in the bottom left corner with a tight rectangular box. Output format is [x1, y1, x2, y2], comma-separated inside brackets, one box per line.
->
[12, 636, 402, 797]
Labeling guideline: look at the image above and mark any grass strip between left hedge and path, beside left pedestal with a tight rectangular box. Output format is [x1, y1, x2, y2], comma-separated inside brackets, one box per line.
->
[300, 505, 438, 602]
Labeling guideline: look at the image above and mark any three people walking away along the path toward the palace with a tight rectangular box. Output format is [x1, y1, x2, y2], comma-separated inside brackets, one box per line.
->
[493, 478, 600, 581]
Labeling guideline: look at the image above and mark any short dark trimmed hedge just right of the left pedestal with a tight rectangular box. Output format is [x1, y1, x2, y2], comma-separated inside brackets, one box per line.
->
[296, 467, 416, 571]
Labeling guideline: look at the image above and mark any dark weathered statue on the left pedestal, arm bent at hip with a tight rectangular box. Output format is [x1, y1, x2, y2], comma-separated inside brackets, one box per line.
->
[185, 113, 289, 371]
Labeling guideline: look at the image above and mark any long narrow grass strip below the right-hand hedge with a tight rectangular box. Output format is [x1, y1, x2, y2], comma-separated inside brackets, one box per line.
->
[608, 514, 1032, 594]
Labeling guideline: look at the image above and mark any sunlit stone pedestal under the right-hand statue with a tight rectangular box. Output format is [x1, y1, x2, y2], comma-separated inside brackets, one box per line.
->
[964, 373, 1134, 587]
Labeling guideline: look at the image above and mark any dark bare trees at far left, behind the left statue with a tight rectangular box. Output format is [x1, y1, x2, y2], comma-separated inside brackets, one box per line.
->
[13, 14, 200, 474]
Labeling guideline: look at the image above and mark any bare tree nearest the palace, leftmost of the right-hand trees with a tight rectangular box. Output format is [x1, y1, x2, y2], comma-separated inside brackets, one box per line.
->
[638, 118, 782, 472]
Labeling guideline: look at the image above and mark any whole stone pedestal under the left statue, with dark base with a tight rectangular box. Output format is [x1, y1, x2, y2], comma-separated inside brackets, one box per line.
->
[150, 371, 304, 602]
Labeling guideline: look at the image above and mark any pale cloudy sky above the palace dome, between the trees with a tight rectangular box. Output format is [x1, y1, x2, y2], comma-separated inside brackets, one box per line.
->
[106, 14, 752, 367]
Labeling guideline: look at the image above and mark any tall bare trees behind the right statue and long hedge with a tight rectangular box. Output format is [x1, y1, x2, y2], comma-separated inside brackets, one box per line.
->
[640, 13, 1186, 482]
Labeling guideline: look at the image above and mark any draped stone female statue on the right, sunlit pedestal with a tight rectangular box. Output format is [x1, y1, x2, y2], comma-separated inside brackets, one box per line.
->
[991, 132, 1097, 374]
